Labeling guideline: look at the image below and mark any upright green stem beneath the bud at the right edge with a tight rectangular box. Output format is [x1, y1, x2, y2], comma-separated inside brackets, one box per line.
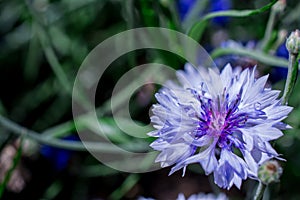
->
[282, 53, 299, 105]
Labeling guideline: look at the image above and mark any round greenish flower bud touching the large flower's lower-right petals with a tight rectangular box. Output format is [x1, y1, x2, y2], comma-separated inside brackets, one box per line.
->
[258, 160, 282, 185]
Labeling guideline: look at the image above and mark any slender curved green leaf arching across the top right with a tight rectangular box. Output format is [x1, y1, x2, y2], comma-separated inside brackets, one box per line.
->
[188, 0, 277, 41]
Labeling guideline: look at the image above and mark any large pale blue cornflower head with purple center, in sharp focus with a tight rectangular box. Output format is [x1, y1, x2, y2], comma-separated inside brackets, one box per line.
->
[149, 64, 292, 189]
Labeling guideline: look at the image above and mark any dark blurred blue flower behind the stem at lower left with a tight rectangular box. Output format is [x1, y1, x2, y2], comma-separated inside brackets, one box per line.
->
[40, 135, 79, 171]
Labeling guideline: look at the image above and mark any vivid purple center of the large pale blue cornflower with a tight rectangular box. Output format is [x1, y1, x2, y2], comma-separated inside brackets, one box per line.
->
[195, 92, 248, 149]
